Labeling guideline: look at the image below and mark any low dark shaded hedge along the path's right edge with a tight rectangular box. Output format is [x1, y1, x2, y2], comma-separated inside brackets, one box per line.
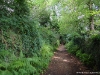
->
[66, 32, 100, 71]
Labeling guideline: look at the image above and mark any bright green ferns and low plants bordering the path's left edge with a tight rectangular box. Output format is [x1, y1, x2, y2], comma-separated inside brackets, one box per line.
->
[0, 45, 53, 75]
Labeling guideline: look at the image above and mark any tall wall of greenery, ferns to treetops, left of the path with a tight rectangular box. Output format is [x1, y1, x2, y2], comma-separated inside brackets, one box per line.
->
[0, 0, 58, 75]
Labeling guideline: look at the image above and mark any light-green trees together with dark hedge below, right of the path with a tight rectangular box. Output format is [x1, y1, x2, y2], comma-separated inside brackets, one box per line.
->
[59, 0, 100, 71]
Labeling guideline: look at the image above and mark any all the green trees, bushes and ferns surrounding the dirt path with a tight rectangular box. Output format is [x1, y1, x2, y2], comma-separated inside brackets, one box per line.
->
[0, 0, 100, 75]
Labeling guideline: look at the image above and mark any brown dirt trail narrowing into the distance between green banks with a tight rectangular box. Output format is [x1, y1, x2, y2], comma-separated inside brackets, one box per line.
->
[43, 45, 89, 75]
